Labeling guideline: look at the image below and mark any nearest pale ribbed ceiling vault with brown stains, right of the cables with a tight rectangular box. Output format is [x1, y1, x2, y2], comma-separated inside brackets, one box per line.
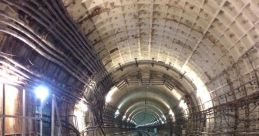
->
[63, 0, 259, 82]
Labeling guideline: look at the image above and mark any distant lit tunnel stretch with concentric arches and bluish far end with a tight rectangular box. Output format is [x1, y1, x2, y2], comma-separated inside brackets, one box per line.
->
[105, 84, 187, 126]
